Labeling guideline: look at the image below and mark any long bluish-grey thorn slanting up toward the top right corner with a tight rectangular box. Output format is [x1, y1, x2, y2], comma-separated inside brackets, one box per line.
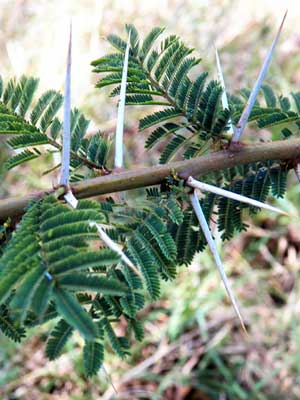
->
[231, 11, 287, 147]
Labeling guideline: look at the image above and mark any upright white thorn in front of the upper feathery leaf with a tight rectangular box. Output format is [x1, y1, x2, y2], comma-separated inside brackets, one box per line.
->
[115, 32, 130, 168]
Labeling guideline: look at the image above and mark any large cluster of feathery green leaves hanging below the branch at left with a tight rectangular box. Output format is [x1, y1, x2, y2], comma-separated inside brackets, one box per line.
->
[0, 191, 180, 376]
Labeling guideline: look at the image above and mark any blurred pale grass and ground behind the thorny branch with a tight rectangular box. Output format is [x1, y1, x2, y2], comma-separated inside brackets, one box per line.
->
[0, 0, 300, 400]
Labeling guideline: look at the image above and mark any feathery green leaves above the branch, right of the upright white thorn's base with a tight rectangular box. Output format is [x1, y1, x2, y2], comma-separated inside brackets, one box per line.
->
[92, 26, 300, 164]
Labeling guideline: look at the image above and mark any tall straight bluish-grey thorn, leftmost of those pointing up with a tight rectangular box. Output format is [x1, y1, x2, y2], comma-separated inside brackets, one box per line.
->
[60, 23, 72, 186]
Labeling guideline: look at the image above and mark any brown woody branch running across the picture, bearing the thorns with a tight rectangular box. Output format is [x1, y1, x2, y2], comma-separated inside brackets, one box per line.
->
[0, 139, 300, 221]
